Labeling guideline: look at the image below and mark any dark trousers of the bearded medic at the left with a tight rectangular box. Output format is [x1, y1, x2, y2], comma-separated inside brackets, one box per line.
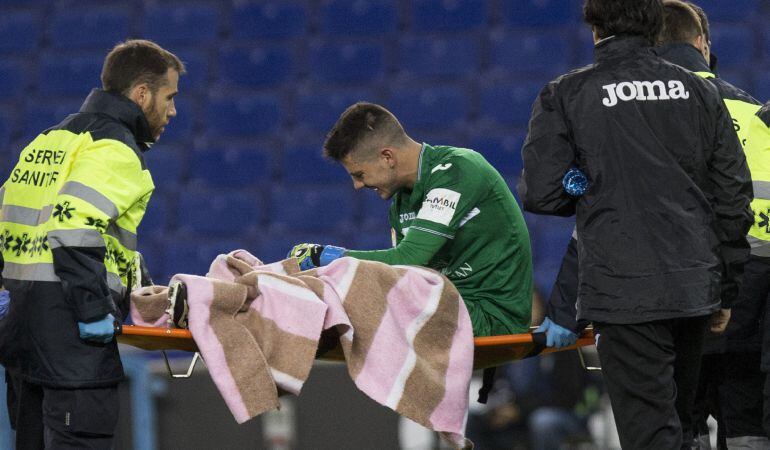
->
[6, 372, 119, 450]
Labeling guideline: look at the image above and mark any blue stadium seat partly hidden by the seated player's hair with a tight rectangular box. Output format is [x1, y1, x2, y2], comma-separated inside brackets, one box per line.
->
[295, 87, 378, 132]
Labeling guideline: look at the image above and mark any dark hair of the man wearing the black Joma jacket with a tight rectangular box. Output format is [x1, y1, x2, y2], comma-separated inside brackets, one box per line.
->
[583, 0, 663, 45]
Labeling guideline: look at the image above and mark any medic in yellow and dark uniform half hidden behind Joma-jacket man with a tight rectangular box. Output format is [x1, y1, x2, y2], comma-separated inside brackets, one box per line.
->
[656, 0, 770, 449]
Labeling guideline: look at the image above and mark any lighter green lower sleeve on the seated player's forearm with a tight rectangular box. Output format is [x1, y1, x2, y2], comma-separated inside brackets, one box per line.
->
[345, 230, 448, 266]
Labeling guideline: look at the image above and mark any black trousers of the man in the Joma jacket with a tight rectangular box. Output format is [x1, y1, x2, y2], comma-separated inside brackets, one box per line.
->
[594, 316, 708, 450]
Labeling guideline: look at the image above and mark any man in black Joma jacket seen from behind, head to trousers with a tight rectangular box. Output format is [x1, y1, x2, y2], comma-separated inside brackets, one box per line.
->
[519, 0, 753, 449]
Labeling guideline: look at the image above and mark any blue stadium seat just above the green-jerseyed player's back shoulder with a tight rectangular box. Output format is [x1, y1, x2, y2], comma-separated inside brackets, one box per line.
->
[470, 129, 526, 177]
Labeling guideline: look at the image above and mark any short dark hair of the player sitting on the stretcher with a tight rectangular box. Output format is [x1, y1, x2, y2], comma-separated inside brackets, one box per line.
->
[324, 102, 407, 161]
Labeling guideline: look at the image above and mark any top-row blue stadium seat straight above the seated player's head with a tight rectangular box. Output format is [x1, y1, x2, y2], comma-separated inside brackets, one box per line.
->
[321, 0, 397, 36]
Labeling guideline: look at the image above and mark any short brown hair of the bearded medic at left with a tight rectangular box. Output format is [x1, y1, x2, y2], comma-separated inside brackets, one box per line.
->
[102, 39, 185, 95]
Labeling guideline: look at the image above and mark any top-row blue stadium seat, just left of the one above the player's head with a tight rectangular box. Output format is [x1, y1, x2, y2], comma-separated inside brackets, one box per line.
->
[231, 1, 308, 39]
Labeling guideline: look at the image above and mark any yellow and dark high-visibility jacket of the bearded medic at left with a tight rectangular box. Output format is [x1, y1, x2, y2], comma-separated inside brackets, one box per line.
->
[0, 89, 154, 387]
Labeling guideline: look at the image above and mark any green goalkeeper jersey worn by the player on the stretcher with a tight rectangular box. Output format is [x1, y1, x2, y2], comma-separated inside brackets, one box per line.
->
[348, 144, 532, 336]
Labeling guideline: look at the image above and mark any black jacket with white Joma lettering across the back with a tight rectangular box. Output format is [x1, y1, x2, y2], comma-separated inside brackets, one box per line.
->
[519, 36, 753, 323]
